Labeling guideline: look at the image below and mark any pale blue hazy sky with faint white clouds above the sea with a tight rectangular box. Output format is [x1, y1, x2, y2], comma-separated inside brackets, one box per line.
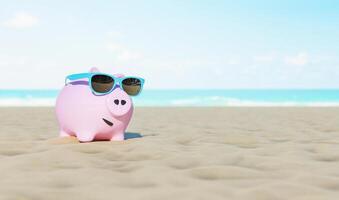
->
[0, 0, 339, 89]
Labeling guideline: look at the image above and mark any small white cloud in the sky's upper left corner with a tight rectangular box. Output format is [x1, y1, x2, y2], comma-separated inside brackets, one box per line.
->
[3, 12, 39, 29]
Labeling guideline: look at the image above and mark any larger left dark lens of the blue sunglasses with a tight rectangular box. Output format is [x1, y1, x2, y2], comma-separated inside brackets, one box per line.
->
[91, 75, 114, 93]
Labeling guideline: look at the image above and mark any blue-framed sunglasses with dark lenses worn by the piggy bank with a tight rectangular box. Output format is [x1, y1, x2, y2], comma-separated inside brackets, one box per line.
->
[65, 73, 145, 96]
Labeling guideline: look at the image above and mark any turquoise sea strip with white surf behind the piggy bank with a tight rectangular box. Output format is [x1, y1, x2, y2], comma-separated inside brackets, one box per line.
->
[0, 89, 339, 106]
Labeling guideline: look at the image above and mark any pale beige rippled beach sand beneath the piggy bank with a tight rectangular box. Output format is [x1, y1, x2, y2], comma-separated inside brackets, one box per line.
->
[0, 108, 339, 200]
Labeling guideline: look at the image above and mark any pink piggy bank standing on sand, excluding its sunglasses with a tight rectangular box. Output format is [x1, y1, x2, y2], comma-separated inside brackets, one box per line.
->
[56, 68, 133, 142]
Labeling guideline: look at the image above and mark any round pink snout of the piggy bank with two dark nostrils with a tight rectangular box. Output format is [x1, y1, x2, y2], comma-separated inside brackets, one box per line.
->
[107, 88, 132, 117]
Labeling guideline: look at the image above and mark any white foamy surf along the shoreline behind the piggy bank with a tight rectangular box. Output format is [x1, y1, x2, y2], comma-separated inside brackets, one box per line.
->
[0, 96, 339, 107]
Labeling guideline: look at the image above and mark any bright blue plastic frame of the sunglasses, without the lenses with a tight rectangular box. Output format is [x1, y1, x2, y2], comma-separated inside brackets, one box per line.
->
[65, 73, 145, 96]
